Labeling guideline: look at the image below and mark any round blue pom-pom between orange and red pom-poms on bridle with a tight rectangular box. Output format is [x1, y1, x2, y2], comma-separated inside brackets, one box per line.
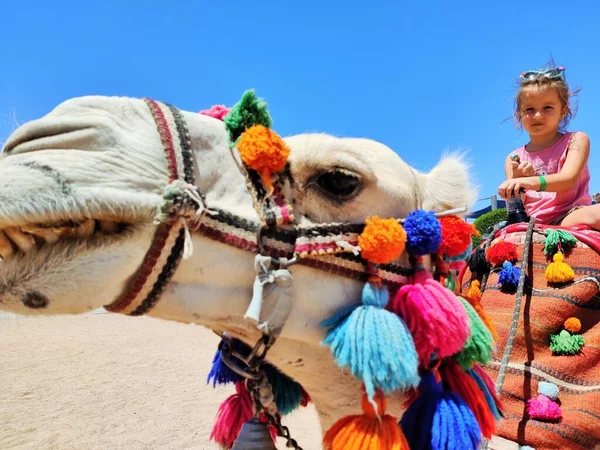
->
[403, 209, 442, 256]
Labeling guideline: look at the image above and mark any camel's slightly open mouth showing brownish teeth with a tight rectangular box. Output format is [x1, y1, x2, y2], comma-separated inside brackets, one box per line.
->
[0, 219, 131, 263]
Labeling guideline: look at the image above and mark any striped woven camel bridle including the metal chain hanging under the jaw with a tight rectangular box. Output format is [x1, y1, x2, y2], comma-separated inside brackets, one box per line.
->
[105, 93, 464, 449]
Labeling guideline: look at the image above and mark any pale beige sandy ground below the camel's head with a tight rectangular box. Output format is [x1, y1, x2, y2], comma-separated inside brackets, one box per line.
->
[0, 314, 321, 450]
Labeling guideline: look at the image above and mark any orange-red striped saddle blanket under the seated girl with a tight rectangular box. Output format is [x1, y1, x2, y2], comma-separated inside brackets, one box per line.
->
[460, 224, 600, 450]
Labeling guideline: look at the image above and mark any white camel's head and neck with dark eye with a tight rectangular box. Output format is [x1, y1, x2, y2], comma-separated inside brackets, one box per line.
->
[0, 96, 492, 448]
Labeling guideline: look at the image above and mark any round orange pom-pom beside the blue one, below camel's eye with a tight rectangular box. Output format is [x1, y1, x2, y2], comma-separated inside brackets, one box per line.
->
[358, 216, 406, 264]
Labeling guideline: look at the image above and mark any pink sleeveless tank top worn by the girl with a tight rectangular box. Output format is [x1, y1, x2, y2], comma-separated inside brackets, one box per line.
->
[513, 132, 592, 224]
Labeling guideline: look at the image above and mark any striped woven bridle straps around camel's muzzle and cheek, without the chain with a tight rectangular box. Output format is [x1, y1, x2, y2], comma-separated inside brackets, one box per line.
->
[105, 99, 452, 316]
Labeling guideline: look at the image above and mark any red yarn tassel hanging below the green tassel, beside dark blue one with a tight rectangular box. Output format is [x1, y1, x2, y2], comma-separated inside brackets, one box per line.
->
[440, 360, 496, 439]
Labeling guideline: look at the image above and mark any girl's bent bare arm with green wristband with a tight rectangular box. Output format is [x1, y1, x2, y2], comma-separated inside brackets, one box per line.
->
[498, 132, 590, 198]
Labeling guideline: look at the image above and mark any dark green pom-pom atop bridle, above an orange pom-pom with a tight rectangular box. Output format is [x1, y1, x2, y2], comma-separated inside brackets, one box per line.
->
[223, 89, 271, 143]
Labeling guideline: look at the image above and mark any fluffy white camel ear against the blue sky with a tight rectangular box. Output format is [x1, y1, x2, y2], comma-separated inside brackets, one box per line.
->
[420, 154, 477, 212]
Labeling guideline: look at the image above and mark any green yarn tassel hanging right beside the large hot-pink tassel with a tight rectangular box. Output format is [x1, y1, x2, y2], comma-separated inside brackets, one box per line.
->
[453, 296, 494, 370]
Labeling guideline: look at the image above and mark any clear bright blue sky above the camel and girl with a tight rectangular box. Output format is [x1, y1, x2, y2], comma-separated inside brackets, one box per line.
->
[0, 0, 600, 213]
